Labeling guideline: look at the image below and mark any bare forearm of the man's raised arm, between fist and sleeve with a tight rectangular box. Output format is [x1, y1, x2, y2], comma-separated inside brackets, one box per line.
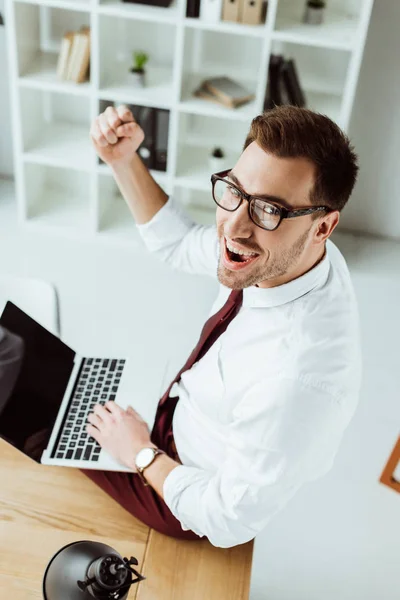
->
[111, 153, 168, 224]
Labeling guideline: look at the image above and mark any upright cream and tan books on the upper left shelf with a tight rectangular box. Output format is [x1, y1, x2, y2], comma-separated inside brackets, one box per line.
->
[57, 26, 90, 83]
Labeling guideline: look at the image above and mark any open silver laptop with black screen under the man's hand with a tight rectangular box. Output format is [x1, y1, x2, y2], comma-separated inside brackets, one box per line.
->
[0, 302, 141, 472]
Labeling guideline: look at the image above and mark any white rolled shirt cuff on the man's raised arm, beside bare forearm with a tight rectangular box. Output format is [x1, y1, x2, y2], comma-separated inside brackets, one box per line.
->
[136, 197, 196, 251]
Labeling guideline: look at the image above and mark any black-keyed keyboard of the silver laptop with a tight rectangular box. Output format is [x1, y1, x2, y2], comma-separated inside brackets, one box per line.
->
[55, 358, 125, 461]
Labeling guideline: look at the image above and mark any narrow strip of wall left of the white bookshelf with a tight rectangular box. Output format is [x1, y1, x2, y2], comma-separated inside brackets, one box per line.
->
[0, 0, 13, 176]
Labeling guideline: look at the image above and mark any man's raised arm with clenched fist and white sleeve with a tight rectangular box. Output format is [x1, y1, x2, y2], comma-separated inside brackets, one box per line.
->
[90, 106, 218, 275]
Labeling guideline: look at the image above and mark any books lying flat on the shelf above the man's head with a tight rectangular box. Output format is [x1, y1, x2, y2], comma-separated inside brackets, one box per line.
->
[193, 76, 255, 108]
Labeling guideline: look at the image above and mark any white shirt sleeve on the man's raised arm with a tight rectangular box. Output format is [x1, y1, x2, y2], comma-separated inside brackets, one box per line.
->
[136, 198, 218, 277]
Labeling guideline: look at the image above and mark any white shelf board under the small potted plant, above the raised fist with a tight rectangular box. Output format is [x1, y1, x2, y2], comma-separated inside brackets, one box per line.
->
[99, 66, 174, 108]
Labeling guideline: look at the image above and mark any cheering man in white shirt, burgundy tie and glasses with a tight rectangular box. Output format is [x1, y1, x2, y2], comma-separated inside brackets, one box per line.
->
[85, 106, 361, 547]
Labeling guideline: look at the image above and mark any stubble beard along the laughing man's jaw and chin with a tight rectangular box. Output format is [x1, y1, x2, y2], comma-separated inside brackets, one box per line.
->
[217, 229, 310, 290]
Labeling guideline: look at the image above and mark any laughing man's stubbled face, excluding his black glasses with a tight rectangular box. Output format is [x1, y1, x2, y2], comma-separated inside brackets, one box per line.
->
[217, 142, 323, 289]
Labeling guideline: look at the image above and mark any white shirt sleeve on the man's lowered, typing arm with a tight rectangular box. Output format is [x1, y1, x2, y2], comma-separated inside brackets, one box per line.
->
[163, 379, 349, 548]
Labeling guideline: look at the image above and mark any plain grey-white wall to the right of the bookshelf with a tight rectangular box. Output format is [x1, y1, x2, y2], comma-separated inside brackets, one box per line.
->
[341, 0, 400, 240]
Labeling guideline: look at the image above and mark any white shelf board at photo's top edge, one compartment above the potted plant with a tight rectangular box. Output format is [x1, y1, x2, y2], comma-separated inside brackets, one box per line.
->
[98, 0, 179, 23]
